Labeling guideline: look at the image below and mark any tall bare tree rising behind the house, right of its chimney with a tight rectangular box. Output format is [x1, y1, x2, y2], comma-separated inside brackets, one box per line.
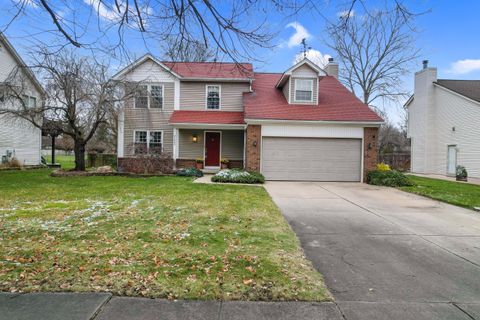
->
[327, 1, 419, 107]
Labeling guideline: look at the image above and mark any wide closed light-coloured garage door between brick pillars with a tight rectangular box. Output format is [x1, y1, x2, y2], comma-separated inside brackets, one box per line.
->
[262, 137, 362, 181]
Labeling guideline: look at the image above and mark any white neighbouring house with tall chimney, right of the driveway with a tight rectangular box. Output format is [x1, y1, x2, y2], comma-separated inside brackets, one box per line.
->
[405, 61, 480, 178]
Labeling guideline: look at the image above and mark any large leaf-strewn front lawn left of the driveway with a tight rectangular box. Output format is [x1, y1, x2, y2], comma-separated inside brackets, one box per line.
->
[0, 169, 330, 301]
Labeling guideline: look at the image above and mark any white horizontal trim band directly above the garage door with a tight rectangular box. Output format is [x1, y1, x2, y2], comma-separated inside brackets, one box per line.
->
[262, 125, 363, 139]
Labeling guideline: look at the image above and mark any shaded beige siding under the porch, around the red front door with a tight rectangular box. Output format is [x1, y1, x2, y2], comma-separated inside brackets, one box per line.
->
[178, 129, 244, 160]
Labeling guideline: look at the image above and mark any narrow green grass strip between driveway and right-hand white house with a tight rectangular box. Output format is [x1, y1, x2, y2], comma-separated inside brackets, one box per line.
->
[400, 175, 480, 209]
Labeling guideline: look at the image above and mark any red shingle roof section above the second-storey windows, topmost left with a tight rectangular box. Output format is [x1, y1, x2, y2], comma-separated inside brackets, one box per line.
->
[162, 62, 253, 79]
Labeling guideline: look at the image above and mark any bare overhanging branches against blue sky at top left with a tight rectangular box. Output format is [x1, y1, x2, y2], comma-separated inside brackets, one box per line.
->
[2, 0, 286, 61]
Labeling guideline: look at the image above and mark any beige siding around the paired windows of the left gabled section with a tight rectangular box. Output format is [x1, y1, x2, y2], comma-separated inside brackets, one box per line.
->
[124, 82, 174, 156]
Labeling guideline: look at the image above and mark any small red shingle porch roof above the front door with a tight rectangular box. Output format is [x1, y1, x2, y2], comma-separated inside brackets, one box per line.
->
[170, 110, 245, 124]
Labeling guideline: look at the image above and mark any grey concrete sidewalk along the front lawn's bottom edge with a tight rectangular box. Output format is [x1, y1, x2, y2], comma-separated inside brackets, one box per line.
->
[0, 293, 343, 320]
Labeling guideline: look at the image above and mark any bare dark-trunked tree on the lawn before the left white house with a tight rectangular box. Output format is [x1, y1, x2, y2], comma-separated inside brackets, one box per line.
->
[0, 47, 127, 171]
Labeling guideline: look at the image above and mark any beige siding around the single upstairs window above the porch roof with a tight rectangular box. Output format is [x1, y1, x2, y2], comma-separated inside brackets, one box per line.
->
[180, 81, 249, 111]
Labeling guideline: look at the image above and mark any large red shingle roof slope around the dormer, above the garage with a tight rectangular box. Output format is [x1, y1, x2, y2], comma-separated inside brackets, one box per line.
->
[244, 73, 383, 122]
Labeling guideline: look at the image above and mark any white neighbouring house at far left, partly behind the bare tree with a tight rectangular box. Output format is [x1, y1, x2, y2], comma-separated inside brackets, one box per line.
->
[0, 33, 44, 165]
